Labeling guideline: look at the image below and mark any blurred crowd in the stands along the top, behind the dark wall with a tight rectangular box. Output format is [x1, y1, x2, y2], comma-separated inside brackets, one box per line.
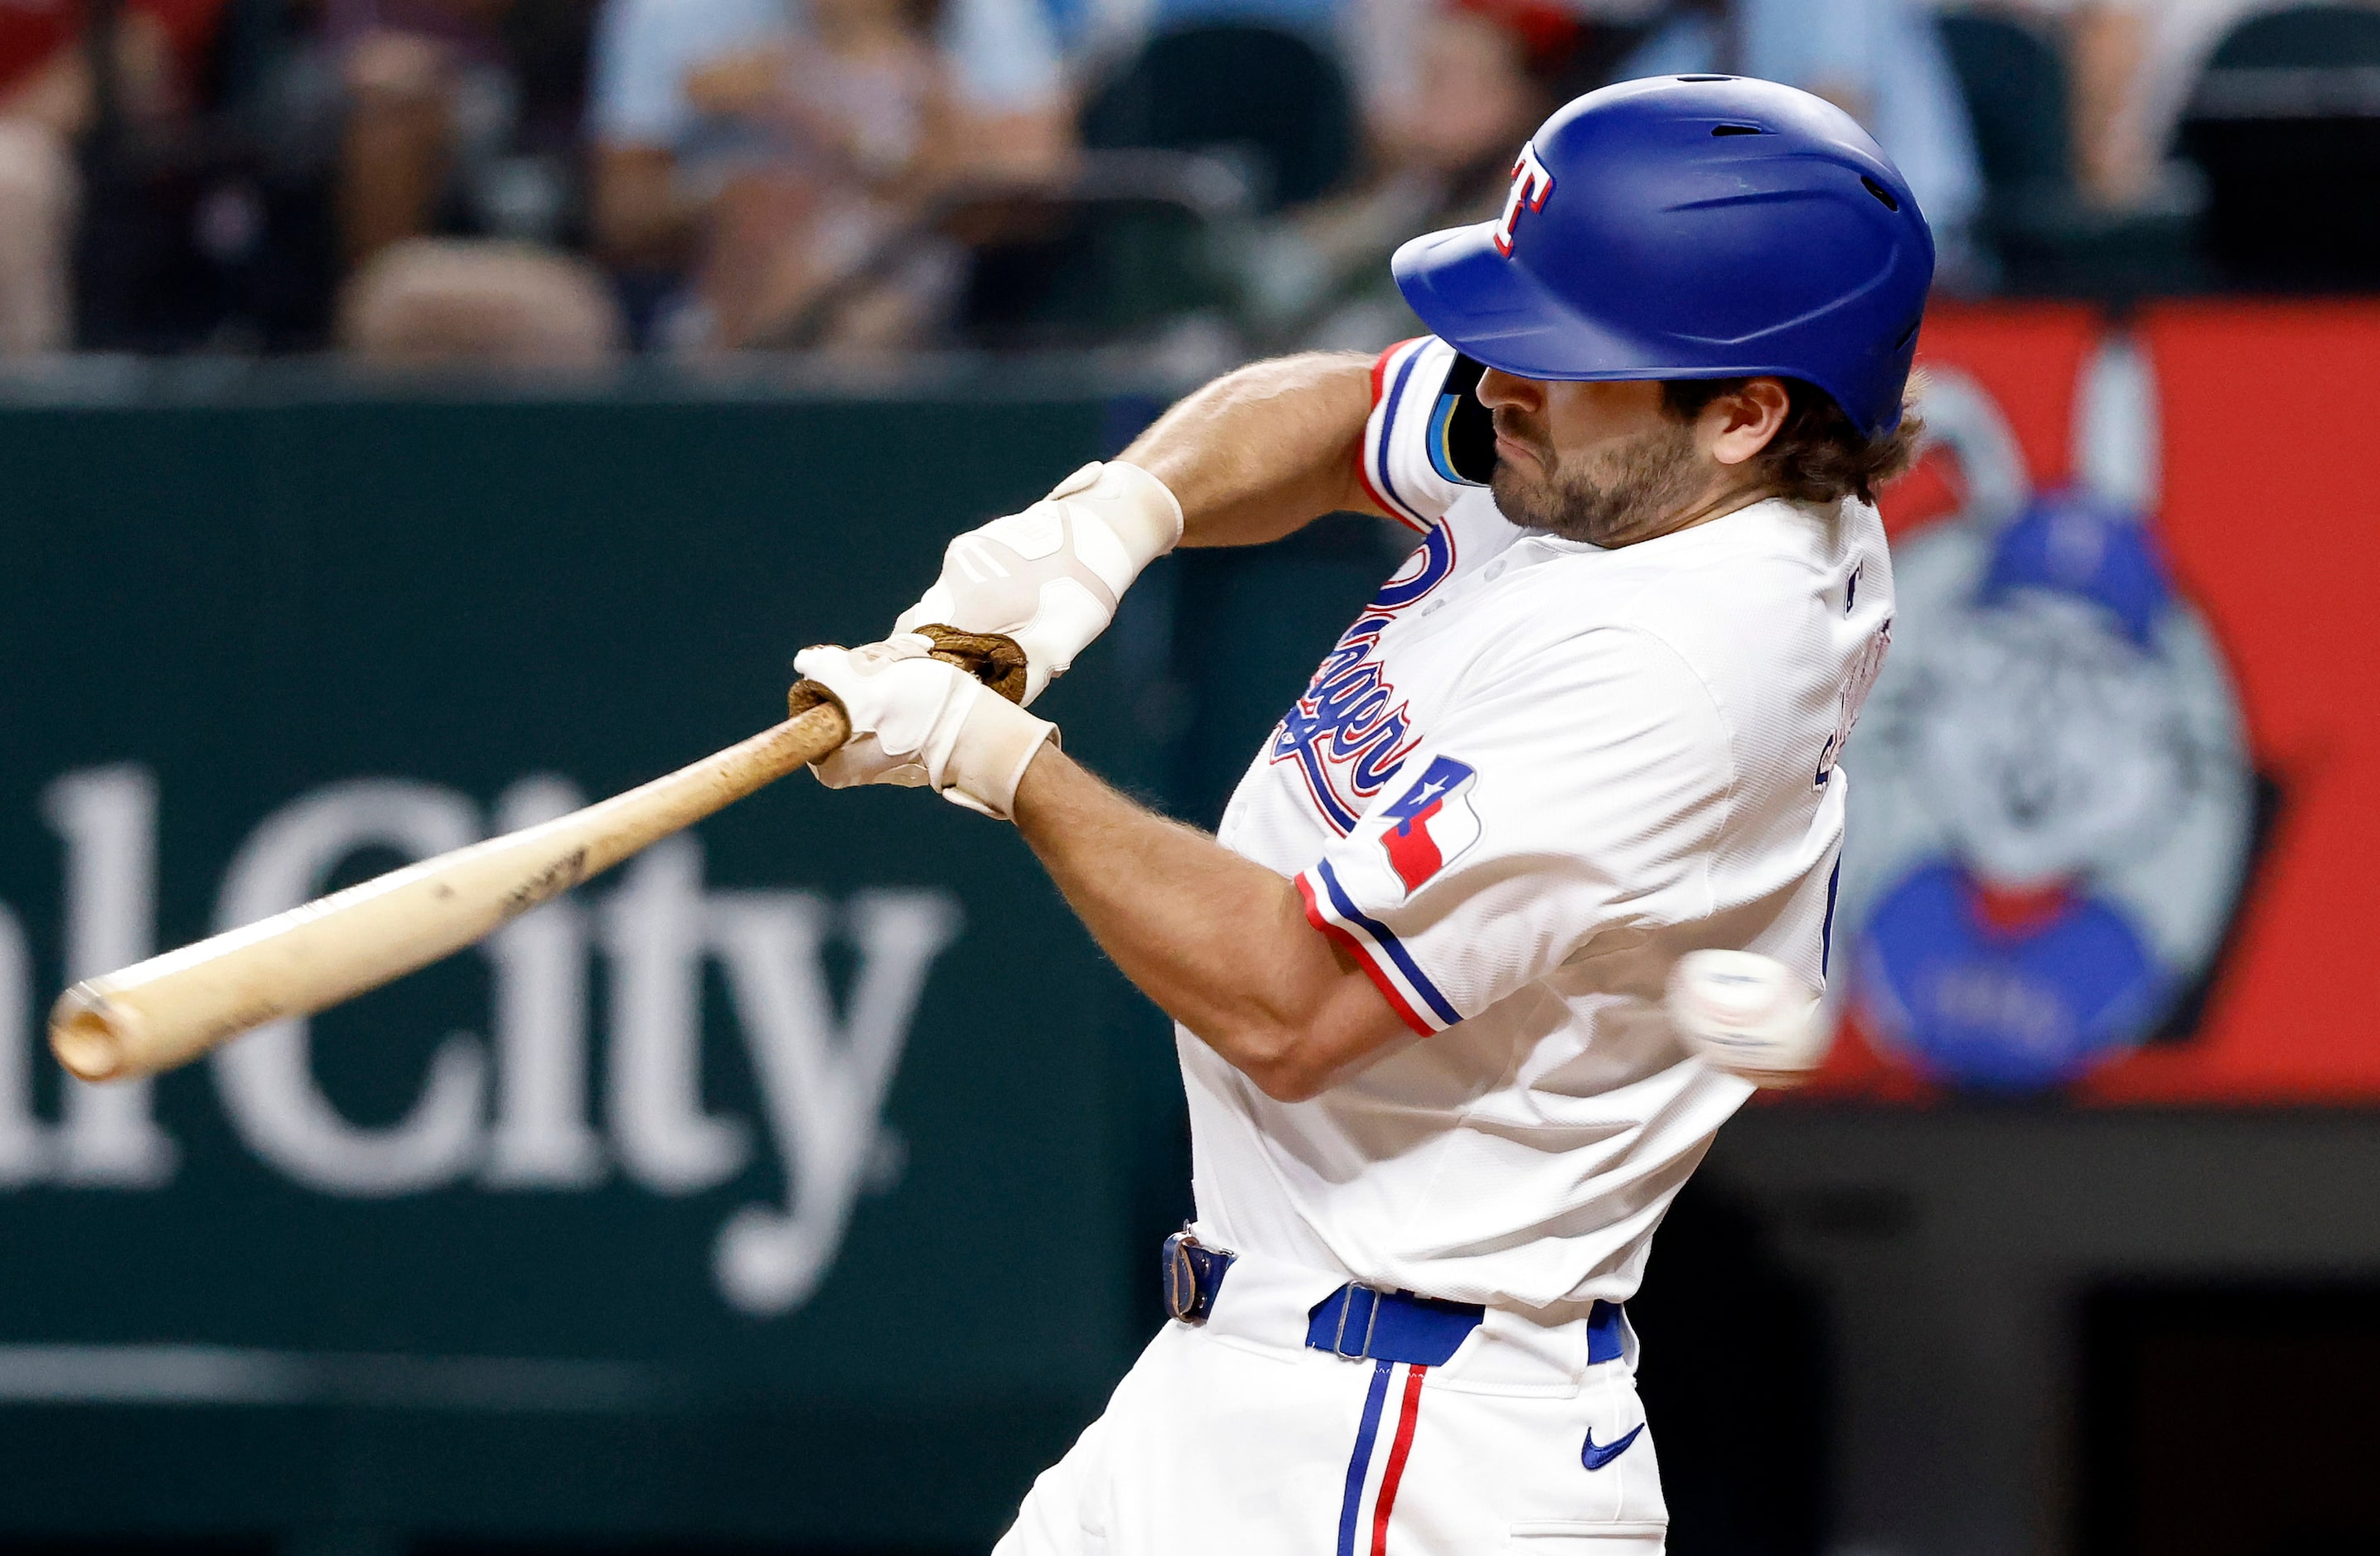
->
[13, 0, 2380, 364]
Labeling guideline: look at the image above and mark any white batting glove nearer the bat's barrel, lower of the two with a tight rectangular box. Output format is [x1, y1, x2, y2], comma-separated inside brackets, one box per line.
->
[792, 633, 1057, 821]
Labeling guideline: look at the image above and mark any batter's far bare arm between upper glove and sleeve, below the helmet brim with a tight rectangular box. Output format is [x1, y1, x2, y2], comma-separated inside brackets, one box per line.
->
[1121, 352, 1381, 545]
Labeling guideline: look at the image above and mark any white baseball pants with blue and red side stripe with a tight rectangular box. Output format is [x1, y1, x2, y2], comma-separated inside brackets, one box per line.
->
[993, 1259, 1668, 1556]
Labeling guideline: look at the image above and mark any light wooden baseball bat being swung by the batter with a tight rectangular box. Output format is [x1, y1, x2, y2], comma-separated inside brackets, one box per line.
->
[50, 702, 852, 1080]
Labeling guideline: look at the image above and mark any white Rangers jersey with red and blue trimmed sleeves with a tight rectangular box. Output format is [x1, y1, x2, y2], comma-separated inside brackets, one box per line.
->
[1178, 341, 1892, 1321]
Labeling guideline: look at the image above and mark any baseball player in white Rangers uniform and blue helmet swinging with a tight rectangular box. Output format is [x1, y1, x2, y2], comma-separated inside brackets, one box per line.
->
[797, 76, 1933, 1556]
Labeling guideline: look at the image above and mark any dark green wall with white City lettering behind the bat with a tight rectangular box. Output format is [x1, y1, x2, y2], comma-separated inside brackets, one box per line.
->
[0, 398, 1218, 1549]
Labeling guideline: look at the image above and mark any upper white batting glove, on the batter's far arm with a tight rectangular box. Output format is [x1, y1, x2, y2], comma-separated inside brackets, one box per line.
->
[892, 461, 1183, 704]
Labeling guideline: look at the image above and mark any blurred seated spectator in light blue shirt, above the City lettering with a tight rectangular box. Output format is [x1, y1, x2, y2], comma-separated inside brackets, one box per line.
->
[590, 0, 1071, 347]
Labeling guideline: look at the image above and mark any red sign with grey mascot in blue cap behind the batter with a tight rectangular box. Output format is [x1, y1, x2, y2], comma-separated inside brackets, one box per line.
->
[1807, 305, 2380, 1104]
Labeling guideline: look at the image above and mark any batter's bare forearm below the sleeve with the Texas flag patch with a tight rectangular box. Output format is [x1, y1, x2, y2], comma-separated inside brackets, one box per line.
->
[1013, 747, 1409, 1102]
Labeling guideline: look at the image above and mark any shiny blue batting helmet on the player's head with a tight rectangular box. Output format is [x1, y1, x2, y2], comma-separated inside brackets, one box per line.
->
[1392, 76, 1933, 437]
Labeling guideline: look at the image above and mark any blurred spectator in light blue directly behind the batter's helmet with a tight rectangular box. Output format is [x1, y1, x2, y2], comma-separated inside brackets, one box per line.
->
[1618, 0, 1982, 286]
